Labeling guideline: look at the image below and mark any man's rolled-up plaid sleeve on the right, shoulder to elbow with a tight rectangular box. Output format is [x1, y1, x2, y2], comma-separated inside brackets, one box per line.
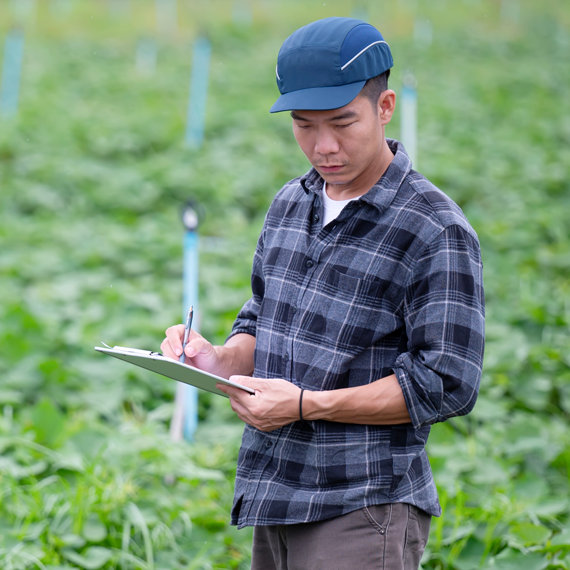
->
[393, 225, 485, 429]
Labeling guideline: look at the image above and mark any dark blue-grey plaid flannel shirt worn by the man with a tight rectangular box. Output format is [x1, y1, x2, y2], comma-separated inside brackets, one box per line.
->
[232, 140, 484, 527]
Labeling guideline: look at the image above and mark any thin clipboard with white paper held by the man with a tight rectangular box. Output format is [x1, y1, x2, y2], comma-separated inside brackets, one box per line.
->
[94, 346, 255, 398]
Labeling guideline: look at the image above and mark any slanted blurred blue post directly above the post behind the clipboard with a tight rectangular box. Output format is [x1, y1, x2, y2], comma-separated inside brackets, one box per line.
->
[186, 38, 212, 148]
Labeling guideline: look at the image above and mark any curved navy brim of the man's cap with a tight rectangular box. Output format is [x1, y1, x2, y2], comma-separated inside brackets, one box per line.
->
[269, 81, 366, 113]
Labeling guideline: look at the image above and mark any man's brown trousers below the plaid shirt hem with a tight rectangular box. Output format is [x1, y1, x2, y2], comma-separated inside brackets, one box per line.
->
[251, 503, 431, 570]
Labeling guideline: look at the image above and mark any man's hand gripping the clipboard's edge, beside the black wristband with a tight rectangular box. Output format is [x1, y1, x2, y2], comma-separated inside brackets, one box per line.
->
[217, 376, 301, 431]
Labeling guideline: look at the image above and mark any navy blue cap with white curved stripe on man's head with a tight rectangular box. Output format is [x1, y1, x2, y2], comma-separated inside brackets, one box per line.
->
[271, 18, 394, 113]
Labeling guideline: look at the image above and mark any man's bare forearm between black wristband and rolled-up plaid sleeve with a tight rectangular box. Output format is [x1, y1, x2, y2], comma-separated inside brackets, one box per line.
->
[303, 374, 411, 425]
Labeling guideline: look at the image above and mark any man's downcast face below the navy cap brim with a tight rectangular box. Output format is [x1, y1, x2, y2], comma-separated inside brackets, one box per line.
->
[291, 91, 393, 199]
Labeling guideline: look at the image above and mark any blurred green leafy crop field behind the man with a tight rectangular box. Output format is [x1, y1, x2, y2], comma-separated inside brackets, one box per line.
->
[0, 0, 570, 570]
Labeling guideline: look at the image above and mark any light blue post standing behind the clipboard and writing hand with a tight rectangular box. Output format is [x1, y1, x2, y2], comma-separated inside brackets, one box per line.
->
[180, 202, 199, 441]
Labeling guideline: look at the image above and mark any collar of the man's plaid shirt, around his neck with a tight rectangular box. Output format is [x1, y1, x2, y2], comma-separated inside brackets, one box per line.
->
[300, 138, 412, 211]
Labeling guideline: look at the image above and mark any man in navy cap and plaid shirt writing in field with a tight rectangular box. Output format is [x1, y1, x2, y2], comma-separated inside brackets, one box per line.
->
[162, 18, 484, 570]
